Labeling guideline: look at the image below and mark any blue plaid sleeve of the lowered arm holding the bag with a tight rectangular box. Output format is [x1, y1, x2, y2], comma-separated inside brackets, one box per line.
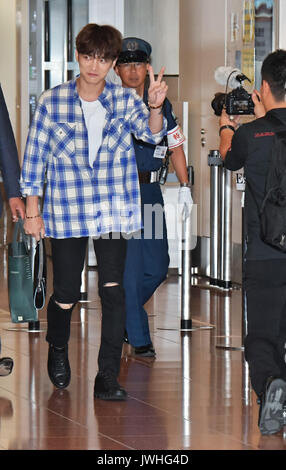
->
[20, 95, 50, 196]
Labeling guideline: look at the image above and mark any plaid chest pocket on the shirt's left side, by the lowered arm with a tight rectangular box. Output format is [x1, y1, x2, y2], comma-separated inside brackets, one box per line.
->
[50, 122, 76, 161]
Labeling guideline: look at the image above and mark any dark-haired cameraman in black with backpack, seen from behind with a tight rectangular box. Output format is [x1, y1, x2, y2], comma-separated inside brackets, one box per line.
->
[220, 50, 286, 434]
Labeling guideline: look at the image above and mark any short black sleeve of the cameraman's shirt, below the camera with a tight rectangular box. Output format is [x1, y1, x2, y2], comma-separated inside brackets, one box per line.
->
[224, 126, 248, 171]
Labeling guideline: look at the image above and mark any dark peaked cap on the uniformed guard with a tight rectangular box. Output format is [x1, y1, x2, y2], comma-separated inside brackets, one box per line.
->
[117, 38, 152, 64]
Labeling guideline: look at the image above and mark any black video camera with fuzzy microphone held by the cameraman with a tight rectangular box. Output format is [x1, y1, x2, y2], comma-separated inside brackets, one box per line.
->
[211, 74, 254, 116]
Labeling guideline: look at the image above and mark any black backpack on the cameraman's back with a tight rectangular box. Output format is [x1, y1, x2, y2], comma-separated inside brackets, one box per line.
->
[246, 115, 286, 253]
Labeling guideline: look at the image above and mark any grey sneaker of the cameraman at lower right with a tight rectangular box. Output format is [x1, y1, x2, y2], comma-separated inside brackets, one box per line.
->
[258, 377, 286, 434]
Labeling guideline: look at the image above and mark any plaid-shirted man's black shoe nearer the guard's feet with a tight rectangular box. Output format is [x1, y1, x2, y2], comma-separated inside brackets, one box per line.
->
[94, 372, 127, 401]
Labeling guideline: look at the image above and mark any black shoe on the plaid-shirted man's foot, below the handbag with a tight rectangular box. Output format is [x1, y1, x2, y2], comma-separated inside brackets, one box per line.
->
[48, 344, 71, 388]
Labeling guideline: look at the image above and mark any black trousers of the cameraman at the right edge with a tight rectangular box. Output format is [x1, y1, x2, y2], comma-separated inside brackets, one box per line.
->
[244, 259, 286, 395]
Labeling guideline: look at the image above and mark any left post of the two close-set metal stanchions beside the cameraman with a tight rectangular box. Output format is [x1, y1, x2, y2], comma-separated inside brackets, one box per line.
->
[208, 150, 223, 286]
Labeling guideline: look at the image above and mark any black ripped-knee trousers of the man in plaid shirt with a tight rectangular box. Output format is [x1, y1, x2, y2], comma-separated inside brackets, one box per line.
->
[47, 234, 126, 375]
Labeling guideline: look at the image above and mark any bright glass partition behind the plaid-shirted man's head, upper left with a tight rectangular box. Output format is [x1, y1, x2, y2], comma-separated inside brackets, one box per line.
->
[29, 0, 89, 121]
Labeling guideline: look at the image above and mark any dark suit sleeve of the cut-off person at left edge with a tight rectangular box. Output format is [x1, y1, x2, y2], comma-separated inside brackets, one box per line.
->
[0, 86, 21, 199]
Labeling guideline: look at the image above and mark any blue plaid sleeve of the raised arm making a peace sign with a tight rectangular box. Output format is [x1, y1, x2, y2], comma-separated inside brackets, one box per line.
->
[127, 89, 167, 145]
